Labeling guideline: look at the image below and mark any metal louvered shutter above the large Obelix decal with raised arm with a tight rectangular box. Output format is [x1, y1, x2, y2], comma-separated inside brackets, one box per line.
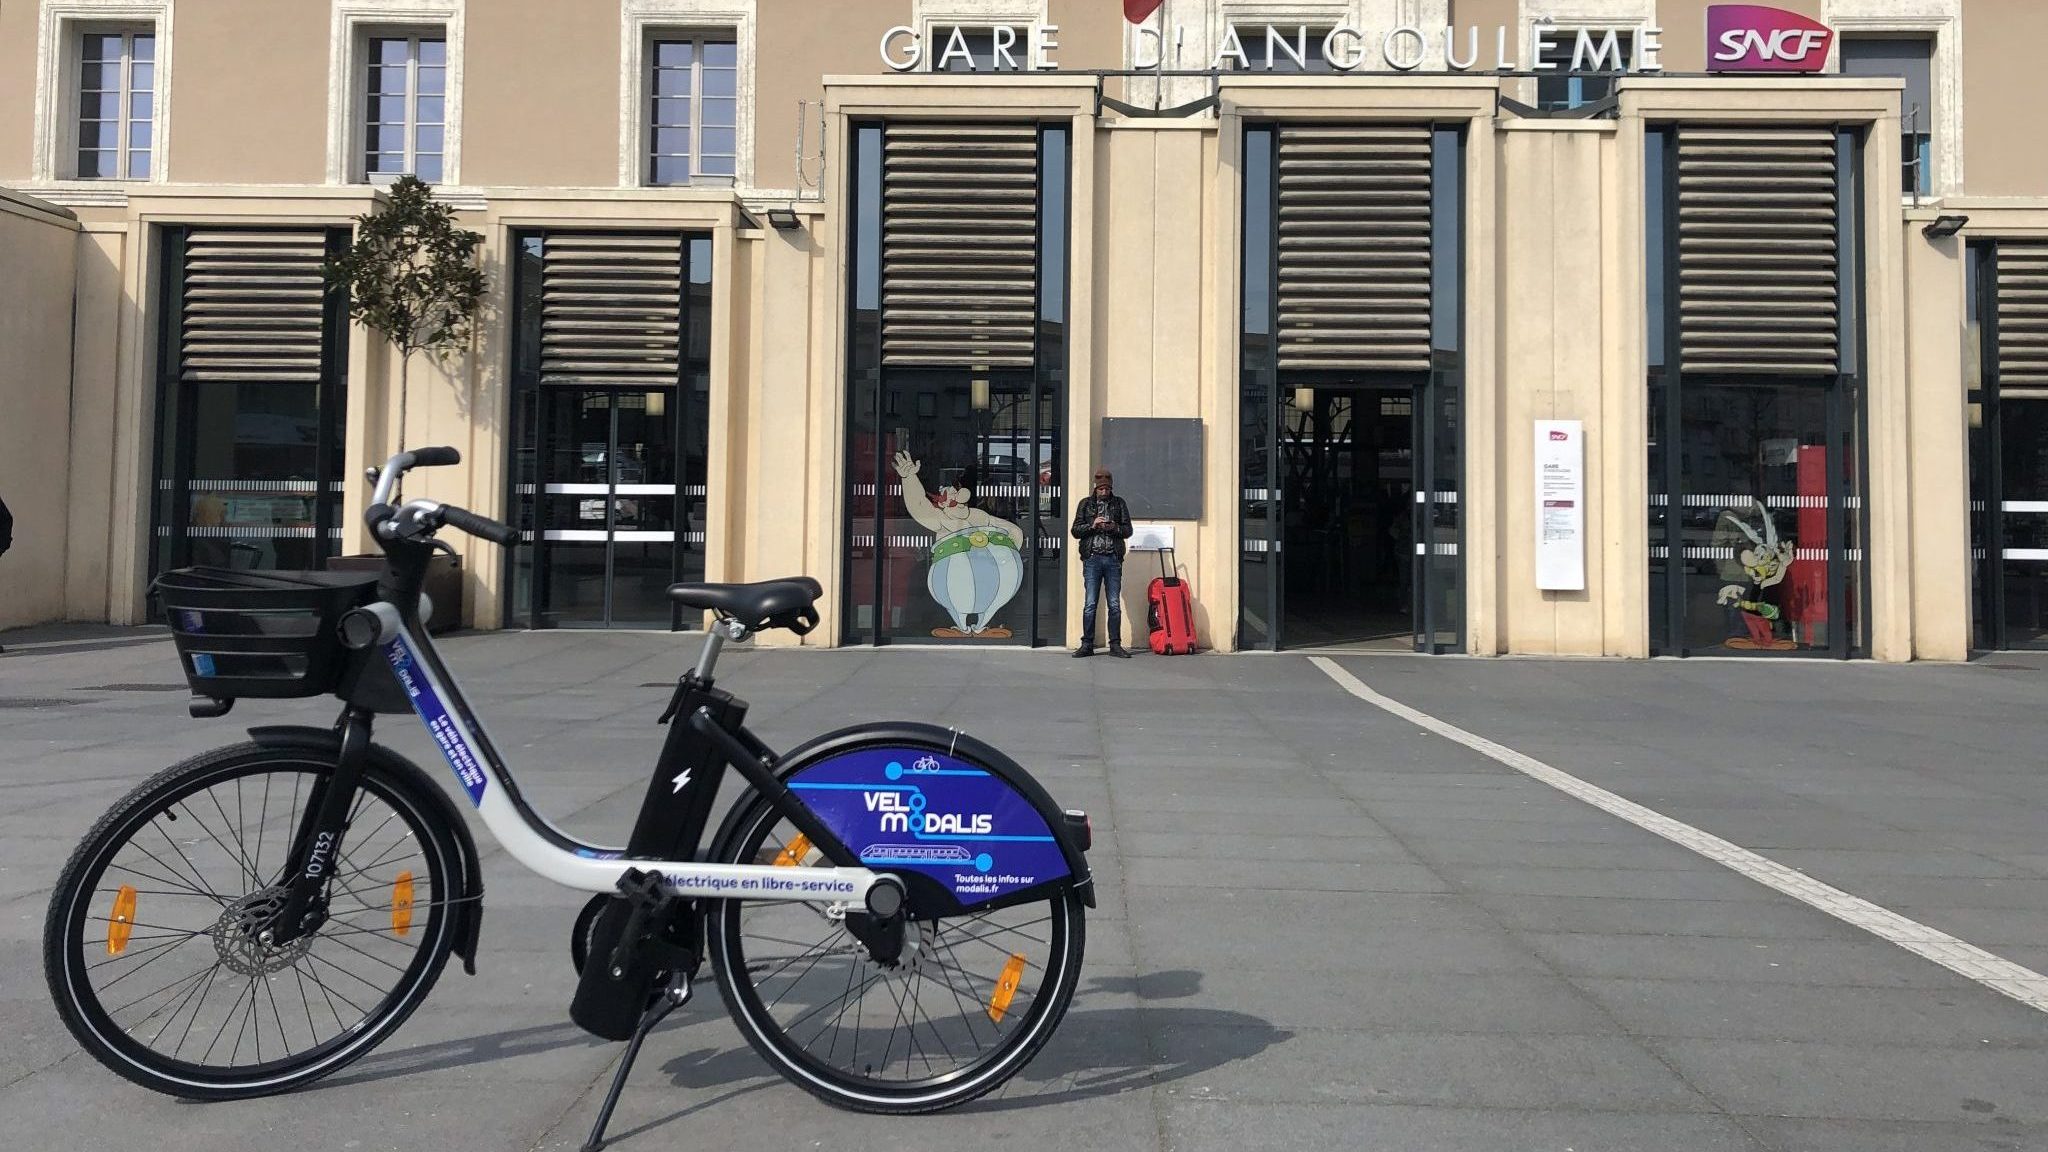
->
[883, 123, 1038, 367]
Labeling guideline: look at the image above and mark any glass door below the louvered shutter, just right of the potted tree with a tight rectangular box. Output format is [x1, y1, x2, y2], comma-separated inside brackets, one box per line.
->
[535, 387, 684, 627]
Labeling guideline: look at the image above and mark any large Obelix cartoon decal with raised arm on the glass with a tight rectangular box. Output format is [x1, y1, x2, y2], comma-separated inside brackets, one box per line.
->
[895, 451, 1024, 640]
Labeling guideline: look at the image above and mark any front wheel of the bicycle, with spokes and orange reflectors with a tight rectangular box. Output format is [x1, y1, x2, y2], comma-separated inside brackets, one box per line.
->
[43, 744, 461, 1101]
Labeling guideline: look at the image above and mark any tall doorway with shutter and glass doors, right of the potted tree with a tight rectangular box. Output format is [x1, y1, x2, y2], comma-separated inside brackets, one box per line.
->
[506, 232, 711, 629]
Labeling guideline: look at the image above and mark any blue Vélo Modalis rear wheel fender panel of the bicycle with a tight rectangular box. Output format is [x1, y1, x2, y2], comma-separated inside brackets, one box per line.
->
[721, 722, 1096, 910]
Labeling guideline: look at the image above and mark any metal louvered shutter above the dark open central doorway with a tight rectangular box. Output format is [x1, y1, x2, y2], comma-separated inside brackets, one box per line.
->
[1278, 125, 1430, 371]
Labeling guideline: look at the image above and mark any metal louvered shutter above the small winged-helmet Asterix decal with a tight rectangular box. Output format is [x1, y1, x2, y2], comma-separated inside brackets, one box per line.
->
[1677, 125, 1841, 375]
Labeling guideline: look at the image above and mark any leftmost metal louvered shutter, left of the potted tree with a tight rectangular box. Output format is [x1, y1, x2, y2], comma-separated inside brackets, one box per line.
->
[178, 228, 328, 383]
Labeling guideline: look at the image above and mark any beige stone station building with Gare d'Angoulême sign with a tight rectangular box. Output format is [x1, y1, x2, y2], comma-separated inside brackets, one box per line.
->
[0, 0, 2048, 660]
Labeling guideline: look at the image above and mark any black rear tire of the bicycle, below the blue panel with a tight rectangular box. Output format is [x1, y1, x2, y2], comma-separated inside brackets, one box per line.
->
[705, 793, 1085, 1115]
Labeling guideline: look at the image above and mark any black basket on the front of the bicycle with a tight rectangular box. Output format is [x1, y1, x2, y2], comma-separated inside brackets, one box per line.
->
[156, 568, 377, 699]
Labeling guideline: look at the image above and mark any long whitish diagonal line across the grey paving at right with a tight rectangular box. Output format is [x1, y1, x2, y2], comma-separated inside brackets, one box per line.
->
[1309, 656, 2048, 1013]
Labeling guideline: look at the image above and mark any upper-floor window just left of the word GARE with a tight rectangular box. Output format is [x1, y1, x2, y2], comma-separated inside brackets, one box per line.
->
[647, 37, 739, 184]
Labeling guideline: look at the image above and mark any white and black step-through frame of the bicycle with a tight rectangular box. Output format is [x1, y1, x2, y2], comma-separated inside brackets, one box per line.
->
[346, 590, 877, 904]
